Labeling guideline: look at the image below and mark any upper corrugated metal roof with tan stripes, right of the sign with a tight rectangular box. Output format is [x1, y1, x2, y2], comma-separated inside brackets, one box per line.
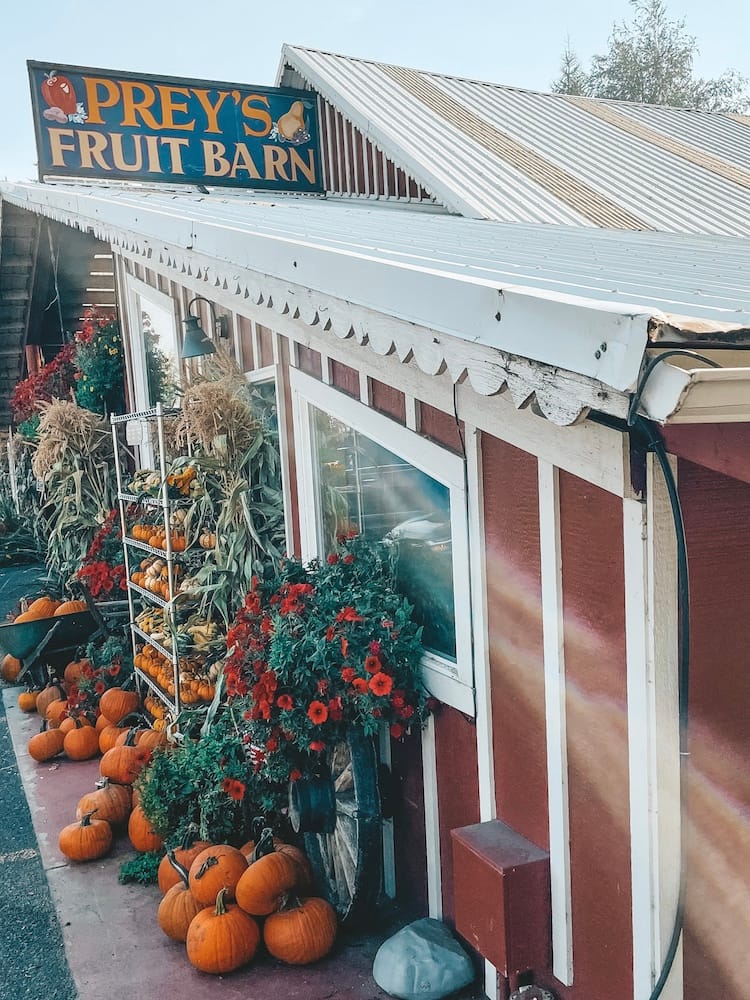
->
[280, 46, 750, 236]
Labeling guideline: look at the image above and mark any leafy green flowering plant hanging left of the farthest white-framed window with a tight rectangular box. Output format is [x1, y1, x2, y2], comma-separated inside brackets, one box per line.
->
[75, 309, 125, 413]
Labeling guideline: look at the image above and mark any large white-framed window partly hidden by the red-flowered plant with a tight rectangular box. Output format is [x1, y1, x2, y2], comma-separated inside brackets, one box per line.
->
[291, 369, 474, 714]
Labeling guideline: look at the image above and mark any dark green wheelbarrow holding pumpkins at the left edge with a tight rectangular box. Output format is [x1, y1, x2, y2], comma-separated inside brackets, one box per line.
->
[0, 610, 102, 684]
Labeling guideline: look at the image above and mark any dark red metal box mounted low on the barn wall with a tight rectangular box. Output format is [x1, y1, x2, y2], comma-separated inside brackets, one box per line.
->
[451, 820, 552, 976]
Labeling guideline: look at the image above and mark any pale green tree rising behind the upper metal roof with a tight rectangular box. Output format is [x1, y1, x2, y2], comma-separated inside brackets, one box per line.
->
[552, 0, 750, 112]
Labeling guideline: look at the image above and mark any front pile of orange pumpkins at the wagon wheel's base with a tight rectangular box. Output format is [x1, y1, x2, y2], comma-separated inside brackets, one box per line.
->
[157, 829, 338, 975]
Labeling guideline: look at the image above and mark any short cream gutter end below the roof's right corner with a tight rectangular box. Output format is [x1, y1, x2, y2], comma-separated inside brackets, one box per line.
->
[641, 362, 750, 424]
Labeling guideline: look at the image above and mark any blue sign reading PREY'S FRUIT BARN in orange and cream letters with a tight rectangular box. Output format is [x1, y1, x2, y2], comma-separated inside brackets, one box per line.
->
[27, 61, 323, 191]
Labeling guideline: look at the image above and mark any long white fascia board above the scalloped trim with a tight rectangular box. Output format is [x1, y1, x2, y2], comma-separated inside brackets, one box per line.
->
[0, 185, 653, 391]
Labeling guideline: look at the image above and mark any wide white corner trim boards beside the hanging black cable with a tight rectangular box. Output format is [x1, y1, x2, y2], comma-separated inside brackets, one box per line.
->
[623, 456, 683, 1000]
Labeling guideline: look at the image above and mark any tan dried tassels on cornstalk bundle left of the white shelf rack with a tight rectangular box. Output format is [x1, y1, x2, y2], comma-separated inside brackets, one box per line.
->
[32, 399, 112, 479]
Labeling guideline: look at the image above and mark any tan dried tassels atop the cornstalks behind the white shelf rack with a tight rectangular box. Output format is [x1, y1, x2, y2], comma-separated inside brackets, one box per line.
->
[176, 351, 258, 459]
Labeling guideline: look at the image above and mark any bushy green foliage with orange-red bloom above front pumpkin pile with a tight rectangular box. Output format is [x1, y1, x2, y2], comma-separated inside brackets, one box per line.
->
[136, 709, 279, 847]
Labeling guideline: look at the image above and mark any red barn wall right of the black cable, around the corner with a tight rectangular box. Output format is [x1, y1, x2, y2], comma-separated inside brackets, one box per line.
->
[678, 461, 750, 1000]
